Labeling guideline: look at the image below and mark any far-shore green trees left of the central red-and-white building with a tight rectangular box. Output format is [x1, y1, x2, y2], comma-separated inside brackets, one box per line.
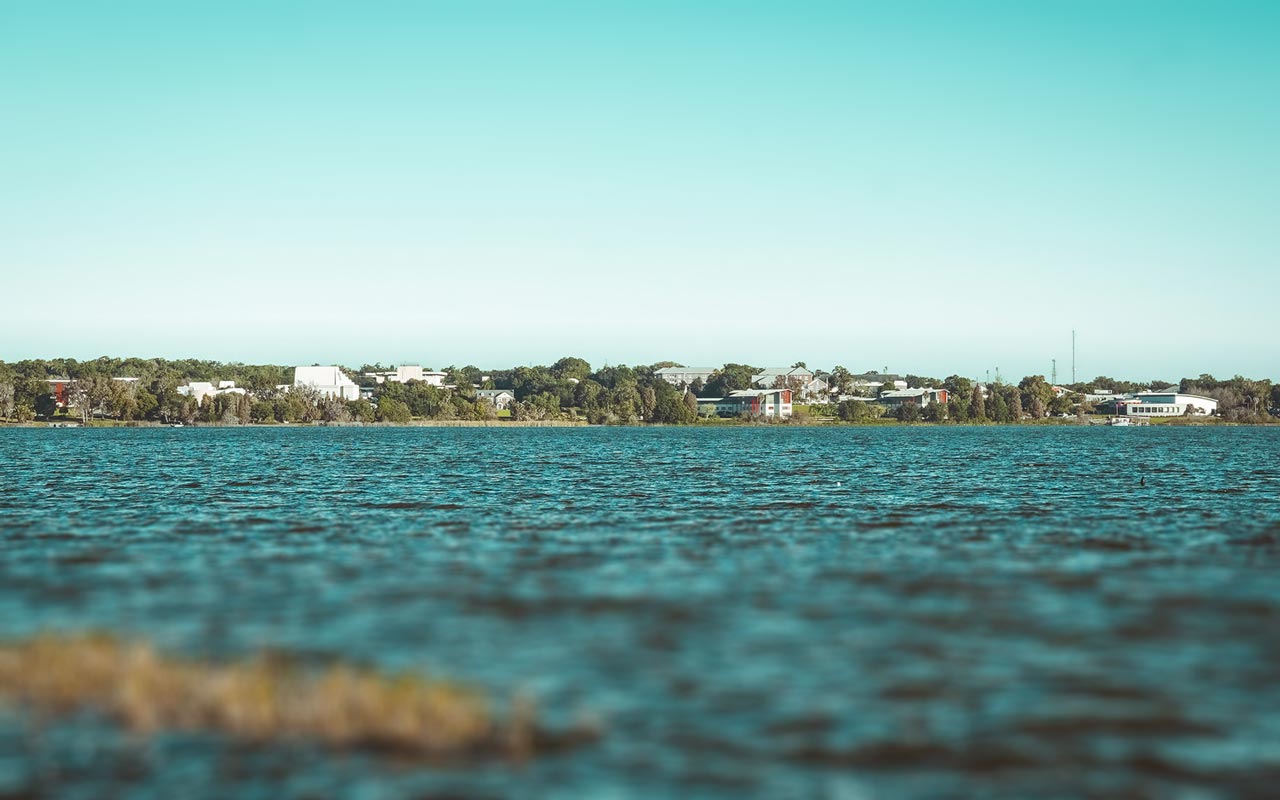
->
[0, 357, 706, 425]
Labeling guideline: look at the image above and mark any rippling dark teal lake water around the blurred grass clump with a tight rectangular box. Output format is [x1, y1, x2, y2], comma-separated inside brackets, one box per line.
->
[0, 428, 1280, 797]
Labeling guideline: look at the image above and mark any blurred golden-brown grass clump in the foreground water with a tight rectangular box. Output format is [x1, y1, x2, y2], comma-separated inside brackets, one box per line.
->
[0, 635, 538, 758]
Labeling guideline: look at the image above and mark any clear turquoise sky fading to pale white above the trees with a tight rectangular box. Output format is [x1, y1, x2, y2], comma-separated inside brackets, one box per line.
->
[0, 0, 1280, 380]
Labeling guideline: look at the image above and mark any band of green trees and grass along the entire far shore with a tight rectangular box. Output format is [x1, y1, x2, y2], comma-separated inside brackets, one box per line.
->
[0, 356, 1280, 428]
